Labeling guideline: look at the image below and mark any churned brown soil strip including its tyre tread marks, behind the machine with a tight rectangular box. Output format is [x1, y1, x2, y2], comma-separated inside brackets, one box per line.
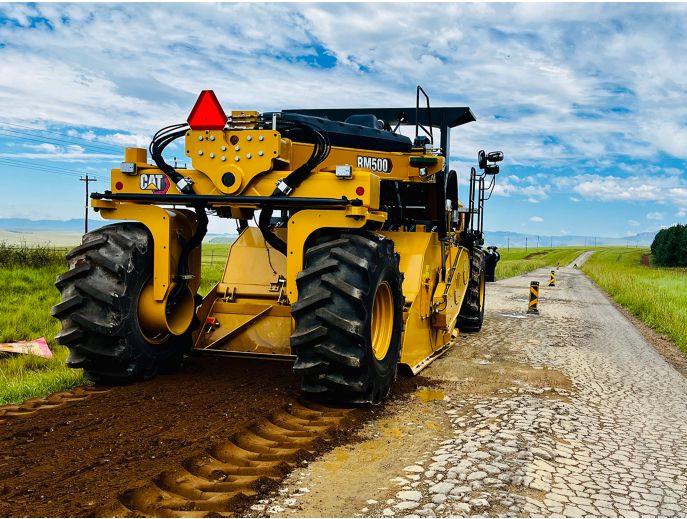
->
[0, 357, 422, 517]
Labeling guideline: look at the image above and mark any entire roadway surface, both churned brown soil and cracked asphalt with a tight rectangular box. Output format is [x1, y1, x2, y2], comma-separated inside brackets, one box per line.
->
[0, 254, 687, 517]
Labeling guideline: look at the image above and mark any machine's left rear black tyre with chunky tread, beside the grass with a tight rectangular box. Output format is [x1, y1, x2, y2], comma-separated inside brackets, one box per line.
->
[52, 223, 191, 384]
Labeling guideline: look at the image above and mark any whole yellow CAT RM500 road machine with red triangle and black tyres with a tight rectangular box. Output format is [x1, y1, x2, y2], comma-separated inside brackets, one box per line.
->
[52, 87, 503, 403]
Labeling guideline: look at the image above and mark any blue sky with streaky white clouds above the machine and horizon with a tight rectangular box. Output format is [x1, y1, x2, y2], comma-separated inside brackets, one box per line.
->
[0, 3, 687, 237]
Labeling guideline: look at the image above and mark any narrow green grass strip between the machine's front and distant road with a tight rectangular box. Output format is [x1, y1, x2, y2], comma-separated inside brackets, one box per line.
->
[496, 247, 589, 280]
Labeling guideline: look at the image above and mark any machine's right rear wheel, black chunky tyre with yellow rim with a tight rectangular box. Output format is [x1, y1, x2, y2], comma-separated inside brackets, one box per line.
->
[291, 232, 404, 404]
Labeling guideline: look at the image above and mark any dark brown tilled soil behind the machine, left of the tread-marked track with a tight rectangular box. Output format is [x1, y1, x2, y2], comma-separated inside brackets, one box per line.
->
[0, 358, 310, 517]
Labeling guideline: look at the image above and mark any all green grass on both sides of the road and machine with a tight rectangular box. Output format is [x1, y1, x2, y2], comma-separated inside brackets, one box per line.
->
[0, 240, 687, 405]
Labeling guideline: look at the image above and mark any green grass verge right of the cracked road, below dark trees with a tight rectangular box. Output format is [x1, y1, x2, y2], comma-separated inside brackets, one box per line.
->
[582, 247, 687, 353]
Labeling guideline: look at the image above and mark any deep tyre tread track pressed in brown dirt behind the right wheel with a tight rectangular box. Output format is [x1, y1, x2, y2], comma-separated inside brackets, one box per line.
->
[103, 401, 360, 517]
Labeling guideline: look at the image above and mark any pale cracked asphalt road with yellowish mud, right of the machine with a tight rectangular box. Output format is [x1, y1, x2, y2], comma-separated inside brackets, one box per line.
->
[254, 253, 687, 517]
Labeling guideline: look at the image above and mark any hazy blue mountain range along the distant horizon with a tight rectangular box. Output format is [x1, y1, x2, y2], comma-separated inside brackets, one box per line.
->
[0, 218, 658, 248]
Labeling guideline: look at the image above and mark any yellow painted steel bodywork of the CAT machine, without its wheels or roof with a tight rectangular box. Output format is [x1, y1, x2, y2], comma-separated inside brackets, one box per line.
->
[92, 114, 470, 373]
